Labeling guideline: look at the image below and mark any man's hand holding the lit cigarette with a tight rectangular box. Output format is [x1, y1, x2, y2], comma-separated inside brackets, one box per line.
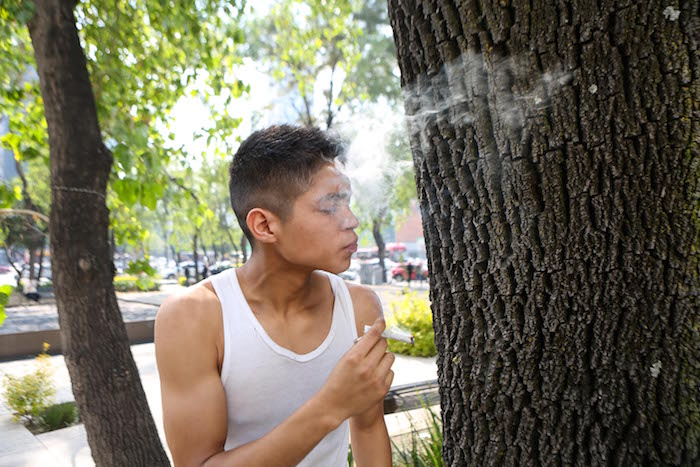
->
[319, 318, 395, 423]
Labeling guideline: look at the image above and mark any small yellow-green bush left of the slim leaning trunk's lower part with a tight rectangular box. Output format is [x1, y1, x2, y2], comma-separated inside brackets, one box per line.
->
[3, 343, 56, 424]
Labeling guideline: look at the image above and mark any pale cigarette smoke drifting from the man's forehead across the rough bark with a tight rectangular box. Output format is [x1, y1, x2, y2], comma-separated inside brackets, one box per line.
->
[336, 54, 573, 214]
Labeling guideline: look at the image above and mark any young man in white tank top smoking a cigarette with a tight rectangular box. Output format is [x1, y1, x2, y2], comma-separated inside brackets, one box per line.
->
[155, 125, 394, 467]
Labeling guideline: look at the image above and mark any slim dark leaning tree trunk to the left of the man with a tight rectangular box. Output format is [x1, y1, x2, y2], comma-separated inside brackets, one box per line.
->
[29, 0, 169, 466]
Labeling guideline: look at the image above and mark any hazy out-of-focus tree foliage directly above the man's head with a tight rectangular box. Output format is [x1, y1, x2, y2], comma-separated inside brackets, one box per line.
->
[246, 0, 400, 128]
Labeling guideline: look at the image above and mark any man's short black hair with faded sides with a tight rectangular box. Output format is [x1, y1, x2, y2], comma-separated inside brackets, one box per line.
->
[228, 125, 345, 245]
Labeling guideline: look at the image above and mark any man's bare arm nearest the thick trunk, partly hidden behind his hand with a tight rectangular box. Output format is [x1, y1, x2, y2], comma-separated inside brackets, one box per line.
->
[349, 285, 394, 467]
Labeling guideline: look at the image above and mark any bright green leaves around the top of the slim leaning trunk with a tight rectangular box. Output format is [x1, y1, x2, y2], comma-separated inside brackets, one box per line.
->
[0, 0, 246, 256]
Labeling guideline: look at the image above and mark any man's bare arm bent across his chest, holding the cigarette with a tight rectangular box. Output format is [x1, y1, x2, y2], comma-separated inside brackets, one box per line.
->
[155, 290, 391, 467]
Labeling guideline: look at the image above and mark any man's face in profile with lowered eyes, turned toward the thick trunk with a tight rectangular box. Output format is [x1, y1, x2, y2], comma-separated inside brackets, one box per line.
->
[277, 164, 358, 274]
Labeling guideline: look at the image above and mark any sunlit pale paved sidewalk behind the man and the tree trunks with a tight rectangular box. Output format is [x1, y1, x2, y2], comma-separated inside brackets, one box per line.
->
[0, 343, 437, 467]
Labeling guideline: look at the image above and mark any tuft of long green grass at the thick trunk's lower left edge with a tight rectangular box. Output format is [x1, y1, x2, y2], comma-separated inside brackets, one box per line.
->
[391, 405, 445, 467]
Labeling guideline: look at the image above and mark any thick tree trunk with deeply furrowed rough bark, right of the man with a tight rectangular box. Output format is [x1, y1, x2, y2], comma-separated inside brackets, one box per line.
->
[389, 0, 700, 466]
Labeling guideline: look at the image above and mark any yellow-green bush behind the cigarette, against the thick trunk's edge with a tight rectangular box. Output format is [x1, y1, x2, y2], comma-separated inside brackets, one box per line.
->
[386, 292, 437, 357]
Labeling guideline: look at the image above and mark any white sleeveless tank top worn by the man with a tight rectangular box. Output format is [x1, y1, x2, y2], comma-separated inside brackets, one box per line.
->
[211, 269, 357, 467]
